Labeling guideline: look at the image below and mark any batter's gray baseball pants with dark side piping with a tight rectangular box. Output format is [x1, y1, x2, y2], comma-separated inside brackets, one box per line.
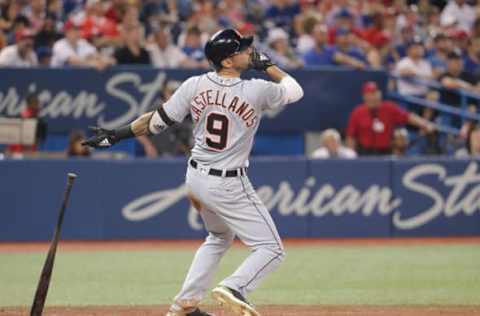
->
[175, 165, 285, 301]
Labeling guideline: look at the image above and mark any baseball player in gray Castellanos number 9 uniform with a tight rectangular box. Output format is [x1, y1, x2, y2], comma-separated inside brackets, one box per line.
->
[85, 29, 303, 316]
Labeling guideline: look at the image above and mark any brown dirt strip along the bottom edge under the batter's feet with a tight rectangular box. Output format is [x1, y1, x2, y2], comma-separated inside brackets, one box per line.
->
[0, 305, 480, 316]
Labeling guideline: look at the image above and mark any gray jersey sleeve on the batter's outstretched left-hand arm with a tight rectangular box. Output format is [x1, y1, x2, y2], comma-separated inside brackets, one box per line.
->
[163, 77, 197, 123]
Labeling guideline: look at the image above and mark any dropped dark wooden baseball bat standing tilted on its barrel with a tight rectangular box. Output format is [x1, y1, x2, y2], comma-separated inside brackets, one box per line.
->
[30, 173, 77, 316]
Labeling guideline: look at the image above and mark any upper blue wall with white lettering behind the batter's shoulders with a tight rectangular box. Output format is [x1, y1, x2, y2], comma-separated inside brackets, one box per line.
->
[0, 67, 387, 134]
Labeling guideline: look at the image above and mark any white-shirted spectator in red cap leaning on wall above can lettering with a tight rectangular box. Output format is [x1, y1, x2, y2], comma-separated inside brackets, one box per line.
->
[52, 20, 115, 70]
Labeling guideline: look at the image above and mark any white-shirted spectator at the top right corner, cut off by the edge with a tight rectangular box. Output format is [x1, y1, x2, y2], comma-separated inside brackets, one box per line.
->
[440, 0, 475, 32]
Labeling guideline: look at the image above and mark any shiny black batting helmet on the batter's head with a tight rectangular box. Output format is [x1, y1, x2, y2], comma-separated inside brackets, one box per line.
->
[205, 29, 253, 67]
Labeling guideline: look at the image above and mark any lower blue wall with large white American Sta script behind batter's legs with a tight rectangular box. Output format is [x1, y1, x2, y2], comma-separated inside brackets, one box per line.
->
[0, 157, 480, 241]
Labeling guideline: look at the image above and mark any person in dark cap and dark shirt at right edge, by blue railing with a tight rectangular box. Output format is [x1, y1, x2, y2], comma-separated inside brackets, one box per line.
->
[439, 51, 480, 128]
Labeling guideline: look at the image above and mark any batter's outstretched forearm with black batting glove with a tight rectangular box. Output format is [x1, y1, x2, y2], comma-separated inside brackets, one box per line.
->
[82, 105, 175, 148]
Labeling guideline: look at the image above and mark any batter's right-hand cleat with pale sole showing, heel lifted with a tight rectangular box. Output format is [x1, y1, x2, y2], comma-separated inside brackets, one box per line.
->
[212, 286, 260, 316]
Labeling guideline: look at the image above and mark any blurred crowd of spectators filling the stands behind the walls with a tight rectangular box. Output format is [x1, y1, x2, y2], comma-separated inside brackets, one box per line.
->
[0, 0, 480, 155]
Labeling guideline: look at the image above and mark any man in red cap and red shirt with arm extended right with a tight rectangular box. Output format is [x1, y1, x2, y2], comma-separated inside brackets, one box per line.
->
[347, 81, 434, 155]
